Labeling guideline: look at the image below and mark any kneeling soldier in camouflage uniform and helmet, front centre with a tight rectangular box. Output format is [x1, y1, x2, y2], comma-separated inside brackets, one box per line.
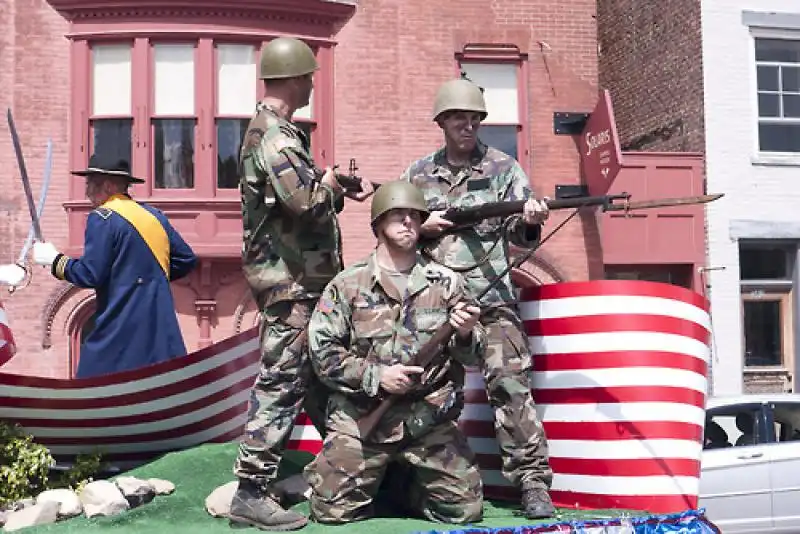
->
[305, 181, 485, 523]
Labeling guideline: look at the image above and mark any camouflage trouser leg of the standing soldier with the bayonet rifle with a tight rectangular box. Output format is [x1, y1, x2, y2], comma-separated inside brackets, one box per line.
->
[481, 308, 553, 489]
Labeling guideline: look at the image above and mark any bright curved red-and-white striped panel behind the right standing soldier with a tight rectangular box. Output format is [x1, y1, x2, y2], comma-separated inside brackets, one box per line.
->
[461, 281, 711, 513]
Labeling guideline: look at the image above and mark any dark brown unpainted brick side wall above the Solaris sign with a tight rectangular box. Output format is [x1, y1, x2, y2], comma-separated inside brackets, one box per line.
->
[597, 0, 704, 152]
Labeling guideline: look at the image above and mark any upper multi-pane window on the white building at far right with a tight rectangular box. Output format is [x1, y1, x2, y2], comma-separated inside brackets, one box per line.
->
[755, 38, 800, 153]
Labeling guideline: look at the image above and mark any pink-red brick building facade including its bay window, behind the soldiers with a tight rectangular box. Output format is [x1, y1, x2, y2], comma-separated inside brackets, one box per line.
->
[0, 0, 602, 377]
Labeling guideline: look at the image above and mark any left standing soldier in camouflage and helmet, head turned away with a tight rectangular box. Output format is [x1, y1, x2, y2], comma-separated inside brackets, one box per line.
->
[230, 38, 371, 530]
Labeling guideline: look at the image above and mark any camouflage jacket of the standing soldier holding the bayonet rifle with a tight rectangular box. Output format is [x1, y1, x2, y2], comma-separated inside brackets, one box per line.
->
[401, 143, 540, 305]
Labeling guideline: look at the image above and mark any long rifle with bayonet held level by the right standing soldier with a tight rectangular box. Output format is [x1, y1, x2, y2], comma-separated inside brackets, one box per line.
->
[442, 193, 723, 225]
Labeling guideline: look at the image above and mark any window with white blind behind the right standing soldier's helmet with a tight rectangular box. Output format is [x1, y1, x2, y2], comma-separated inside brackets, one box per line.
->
[461, 61, 521, 159]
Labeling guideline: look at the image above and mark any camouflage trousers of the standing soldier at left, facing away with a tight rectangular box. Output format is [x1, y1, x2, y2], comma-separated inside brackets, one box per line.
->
[233, 300, 327, 487]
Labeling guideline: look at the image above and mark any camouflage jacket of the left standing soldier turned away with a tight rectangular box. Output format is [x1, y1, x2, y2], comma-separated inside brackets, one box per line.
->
[239, 103, 344, 309]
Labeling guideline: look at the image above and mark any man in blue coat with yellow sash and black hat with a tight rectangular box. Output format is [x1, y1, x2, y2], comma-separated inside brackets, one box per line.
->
[33, 155, 197, 378]
